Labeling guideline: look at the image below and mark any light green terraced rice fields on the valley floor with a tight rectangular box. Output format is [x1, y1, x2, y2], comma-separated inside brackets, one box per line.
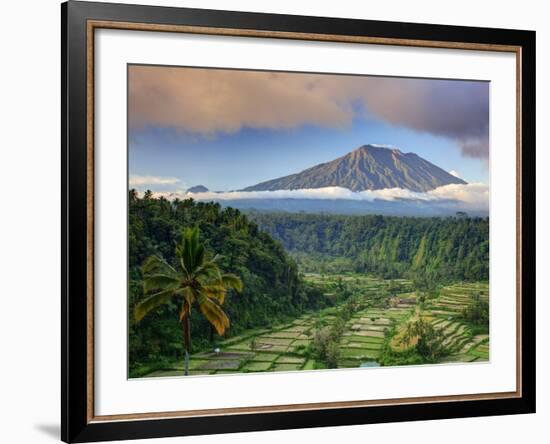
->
[147, 274, 489, 377]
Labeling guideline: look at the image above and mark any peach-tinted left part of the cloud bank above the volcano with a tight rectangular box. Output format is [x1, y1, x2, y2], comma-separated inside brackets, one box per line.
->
[129, 66, 353, 135]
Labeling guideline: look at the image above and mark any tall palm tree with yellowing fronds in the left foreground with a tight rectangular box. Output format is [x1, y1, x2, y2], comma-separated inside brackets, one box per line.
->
[135, 228, 243, 375]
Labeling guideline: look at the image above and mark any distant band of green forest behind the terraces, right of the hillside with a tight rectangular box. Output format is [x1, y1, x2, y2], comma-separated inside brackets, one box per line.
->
[248, 212, 489, 283]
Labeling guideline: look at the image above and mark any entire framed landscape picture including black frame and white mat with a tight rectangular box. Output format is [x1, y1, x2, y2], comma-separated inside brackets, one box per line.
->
[61, 1, 535, 442]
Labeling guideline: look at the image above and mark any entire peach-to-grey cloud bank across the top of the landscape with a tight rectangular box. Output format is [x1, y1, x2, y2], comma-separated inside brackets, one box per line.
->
[129, 66, 489, 158]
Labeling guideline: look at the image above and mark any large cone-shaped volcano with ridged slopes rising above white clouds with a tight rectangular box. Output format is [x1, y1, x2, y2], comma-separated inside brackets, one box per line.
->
[243, 145, 466, 192]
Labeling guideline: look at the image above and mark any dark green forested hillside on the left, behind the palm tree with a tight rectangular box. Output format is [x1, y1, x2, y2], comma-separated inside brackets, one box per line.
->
[128, 190, 331, 374]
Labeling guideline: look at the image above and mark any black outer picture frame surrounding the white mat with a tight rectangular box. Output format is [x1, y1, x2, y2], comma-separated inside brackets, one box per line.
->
[61, 1, 536, 442]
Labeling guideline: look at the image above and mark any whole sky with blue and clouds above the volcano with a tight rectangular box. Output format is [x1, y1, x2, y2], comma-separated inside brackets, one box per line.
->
[128, 65, 489, 192]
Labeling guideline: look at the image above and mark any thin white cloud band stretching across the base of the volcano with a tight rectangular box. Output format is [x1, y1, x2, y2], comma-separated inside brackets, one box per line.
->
[143, 183, 489, 211]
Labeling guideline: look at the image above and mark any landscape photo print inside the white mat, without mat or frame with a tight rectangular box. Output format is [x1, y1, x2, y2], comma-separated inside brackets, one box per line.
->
[127, 65, 494, 378]
